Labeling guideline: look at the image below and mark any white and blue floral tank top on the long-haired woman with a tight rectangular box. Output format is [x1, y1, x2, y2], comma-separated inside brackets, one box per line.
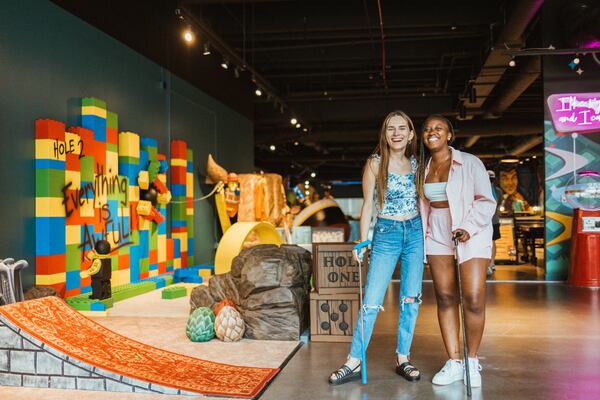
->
[372, 154, 419, 217]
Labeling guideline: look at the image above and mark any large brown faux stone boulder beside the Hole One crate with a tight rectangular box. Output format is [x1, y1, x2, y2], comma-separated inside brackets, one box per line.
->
[191, 245, 311, 340]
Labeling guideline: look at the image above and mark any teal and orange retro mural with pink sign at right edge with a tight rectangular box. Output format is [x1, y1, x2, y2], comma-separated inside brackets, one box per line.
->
[544, 93, 600, 280]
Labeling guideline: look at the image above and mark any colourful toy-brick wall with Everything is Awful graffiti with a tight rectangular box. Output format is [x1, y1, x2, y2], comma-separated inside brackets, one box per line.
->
[35, 98, 194, 298]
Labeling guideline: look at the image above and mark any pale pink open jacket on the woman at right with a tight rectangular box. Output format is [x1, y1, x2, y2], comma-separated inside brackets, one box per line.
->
[419, 147, 496, 258]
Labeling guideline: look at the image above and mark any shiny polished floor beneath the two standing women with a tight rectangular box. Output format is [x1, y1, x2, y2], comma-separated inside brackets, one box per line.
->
[261, 283, 600, 400]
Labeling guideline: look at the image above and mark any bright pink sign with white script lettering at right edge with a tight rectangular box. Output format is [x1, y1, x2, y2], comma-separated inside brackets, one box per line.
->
[548, 93, 600, 134]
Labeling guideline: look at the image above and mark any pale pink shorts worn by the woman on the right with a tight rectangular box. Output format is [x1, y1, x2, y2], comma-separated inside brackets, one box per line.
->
[425, 207, 492, 264]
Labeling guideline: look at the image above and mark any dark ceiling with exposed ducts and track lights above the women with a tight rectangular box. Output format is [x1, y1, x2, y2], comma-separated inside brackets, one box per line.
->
[55, 0, 543, 180]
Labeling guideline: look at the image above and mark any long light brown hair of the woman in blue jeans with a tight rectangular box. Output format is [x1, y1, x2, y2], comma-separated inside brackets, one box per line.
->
[367, 110, 417, 209]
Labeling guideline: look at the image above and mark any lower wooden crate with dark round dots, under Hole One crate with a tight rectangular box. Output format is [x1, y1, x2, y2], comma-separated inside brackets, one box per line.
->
[310, 292, 359, 342]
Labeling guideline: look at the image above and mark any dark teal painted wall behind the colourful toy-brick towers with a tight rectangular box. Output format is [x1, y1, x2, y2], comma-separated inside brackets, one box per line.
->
[0, 0, 254, 287]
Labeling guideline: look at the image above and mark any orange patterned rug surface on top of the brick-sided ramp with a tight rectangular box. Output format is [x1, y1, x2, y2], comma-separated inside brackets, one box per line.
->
[0, 297, 279, 398]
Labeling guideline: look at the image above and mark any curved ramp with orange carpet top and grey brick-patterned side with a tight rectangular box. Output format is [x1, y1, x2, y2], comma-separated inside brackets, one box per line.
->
[0, 297, 279, 398]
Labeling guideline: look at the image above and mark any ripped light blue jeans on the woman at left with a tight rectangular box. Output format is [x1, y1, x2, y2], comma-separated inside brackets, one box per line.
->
[350, 216, 424, 358]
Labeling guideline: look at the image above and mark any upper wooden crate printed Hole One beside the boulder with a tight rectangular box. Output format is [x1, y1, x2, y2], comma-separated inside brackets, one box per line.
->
[312, 243, 368, 294]
